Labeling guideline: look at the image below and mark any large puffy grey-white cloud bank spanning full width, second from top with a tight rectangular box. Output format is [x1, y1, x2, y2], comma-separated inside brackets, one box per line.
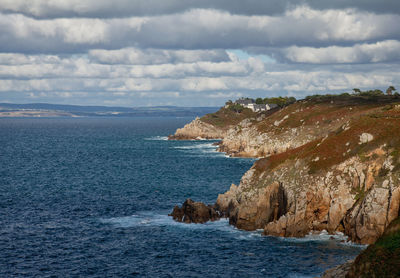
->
[0, 6, 400, 53]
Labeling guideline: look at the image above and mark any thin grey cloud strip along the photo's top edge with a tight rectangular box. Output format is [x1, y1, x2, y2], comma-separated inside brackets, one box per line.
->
[0, 0, 400, 18]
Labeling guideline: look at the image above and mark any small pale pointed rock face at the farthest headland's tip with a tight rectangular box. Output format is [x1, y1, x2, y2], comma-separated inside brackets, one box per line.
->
[168, 118, 226, 140]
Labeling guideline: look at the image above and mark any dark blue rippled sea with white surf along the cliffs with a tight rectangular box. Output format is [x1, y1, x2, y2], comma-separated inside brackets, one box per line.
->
[0, 117, 362, 277]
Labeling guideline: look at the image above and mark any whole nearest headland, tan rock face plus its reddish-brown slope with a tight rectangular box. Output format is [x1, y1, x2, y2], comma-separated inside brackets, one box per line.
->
[217, 101, 400, 243]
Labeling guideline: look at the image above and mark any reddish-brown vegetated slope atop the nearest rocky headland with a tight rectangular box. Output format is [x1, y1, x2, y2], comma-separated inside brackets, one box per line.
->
[255, 102, 400, 174]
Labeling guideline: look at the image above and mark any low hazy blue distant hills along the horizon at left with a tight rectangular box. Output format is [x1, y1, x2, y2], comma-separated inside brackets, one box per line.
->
[0, 103, 219, 117]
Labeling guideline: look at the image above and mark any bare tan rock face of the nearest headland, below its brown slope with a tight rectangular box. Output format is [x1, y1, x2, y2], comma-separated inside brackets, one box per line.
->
[216, 149, 400, 244]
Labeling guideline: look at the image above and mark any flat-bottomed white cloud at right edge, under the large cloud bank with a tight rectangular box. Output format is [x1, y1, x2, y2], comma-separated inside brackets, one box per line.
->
[283, 40, 400, 64]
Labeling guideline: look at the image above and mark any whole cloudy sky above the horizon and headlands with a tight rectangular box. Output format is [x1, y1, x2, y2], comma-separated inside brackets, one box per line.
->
[0, 0, 400, 107]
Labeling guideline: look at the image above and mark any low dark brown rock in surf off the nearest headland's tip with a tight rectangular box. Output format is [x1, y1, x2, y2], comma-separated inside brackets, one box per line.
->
[169, 199, 221, 223]
